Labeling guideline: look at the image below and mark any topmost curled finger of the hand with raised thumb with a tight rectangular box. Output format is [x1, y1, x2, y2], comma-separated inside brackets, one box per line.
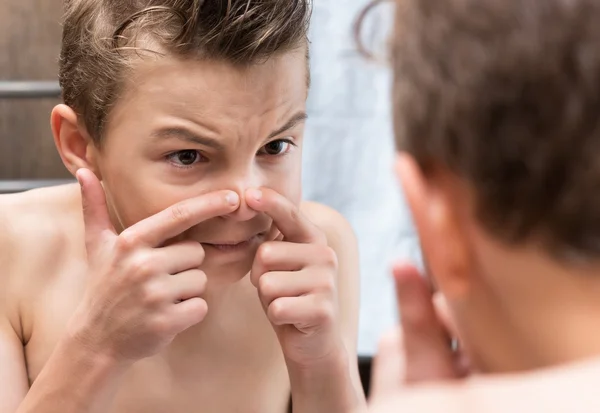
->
[154, 241, 204, 274]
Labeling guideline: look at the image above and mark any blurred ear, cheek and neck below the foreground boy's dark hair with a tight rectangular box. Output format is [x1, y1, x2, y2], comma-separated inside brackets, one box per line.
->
[380, 149, 600, 373]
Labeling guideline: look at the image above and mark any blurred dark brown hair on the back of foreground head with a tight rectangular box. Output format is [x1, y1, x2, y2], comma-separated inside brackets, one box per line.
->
[358, 0, 600, 258]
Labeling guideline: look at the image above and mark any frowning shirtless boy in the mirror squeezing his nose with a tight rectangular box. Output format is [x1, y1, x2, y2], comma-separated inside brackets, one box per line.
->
[0, 0, 364, 413]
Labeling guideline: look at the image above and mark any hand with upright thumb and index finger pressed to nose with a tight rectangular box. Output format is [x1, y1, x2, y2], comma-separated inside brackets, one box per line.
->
[69, 170, 239, 361]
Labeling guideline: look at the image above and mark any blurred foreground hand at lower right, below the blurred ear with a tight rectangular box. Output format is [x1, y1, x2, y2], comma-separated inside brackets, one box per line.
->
[372, 264, 469, 399]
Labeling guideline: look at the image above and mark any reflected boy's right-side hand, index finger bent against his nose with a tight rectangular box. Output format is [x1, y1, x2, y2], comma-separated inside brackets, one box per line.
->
[246, 188, 343, 367]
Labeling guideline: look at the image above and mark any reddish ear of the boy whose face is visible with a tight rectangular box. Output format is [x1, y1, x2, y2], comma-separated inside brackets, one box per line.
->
[50, 104, 100, 178]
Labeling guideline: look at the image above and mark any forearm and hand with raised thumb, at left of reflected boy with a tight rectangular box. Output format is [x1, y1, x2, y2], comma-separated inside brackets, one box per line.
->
[5, 173, 240, 413]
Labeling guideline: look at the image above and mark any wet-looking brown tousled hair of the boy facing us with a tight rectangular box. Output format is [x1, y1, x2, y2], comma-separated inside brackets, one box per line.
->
[59, 0, 311, 143]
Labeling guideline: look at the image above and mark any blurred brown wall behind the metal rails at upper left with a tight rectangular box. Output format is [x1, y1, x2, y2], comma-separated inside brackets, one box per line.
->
[0, 0, 68, 183]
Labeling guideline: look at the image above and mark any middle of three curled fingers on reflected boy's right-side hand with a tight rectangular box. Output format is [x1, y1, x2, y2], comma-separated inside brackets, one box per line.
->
[258, 271, 335, 307]
